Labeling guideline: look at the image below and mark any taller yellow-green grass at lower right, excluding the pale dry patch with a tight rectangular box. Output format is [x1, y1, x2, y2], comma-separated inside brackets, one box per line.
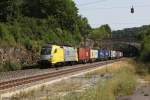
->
[61, 59, 136, 100]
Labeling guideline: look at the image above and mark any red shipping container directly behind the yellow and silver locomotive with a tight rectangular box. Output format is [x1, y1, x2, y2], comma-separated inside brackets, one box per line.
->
[78, 48, 90, 61]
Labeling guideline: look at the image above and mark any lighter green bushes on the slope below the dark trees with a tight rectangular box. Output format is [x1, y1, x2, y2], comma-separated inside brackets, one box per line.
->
[0, 17, 82, 51]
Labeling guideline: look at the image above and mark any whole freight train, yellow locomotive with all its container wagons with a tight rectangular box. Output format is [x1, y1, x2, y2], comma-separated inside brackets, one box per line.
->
[38, 44, 123, 65]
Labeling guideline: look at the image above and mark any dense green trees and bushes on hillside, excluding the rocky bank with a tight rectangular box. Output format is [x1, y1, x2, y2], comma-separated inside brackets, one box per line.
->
[0, 0, 91, 51]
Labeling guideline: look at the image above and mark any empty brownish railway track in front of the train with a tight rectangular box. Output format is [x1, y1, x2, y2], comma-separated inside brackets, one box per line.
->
[0, 59, 121, 91]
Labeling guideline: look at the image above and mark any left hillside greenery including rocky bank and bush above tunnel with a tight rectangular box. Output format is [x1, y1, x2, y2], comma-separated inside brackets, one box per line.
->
[0, 0, 111, 71]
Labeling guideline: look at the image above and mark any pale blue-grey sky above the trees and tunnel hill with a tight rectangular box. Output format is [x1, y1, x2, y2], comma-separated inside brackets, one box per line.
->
[74, 0, 150, 30]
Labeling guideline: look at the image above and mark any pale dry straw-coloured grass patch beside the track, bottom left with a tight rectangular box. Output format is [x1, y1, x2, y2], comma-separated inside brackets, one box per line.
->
[11, 80, 82, 100]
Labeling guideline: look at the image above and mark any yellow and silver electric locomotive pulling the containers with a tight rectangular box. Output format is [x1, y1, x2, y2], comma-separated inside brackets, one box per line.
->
[39, 44, 78, 65]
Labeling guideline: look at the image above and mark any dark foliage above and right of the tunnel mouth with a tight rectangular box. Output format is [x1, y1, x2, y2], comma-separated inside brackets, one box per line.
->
[112, 25, 150, 62]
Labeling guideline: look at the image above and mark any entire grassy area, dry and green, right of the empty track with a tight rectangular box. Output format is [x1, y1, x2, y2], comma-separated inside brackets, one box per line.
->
[8, 59, 150, 100]
